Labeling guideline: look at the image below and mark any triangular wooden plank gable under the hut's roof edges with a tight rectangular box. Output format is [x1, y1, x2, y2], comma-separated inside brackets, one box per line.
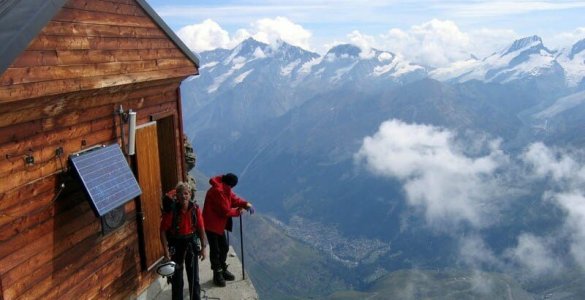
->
[0, 0, 197, 103]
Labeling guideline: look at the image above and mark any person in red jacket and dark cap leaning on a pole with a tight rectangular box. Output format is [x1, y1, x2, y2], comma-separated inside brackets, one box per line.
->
[203, 173, 254, 287]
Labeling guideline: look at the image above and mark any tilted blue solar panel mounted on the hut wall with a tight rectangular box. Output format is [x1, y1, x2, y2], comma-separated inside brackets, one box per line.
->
[69, 144, 142, 217]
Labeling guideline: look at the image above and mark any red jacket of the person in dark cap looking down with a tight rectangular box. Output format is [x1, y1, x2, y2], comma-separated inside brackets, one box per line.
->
[203, 176, 248, 235]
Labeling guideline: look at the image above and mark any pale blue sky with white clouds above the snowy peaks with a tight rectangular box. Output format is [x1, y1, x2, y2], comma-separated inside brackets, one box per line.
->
[147, 0, 585, 64]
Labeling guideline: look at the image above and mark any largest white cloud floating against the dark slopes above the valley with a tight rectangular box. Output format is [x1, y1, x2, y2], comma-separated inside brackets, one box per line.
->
[355, 120, 508, 227]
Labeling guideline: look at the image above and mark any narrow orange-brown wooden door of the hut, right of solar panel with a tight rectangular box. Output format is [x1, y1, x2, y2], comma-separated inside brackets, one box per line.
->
[136, 122, 164, 270]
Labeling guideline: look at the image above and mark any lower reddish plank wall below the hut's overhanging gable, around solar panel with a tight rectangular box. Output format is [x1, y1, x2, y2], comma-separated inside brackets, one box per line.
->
[0, 81, 185, 300]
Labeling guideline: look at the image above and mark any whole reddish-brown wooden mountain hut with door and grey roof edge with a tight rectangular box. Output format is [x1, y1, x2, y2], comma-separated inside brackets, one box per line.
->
[0, 0, 199, 300]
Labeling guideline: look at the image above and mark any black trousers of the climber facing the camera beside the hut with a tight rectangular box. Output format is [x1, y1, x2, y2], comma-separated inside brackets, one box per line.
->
[169, 238, 201, 300]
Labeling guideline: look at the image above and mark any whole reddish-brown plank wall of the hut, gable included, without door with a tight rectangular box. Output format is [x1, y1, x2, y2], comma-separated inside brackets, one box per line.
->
[0, 0, 197, 300]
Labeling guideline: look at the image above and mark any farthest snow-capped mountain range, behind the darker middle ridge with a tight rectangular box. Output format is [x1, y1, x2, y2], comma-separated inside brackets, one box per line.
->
[182, 36, 585, 156]
